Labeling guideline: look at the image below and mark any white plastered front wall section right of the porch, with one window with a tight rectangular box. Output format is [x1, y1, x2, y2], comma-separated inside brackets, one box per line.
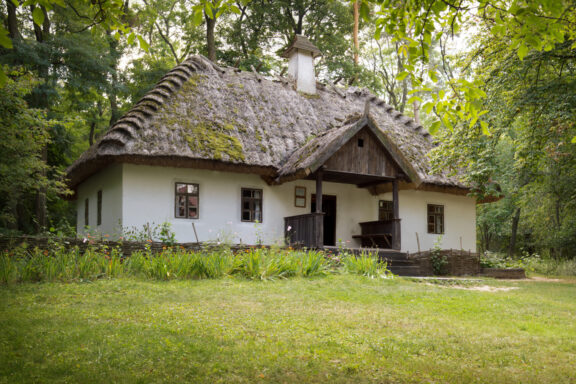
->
[379, 190, 476, 252]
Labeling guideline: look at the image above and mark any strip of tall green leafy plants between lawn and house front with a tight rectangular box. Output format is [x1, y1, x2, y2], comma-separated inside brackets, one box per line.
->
[0, 242, 392, 284]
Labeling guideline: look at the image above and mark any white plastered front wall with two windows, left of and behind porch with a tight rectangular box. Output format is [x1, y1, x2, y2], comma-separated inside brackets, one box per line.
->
[122, 164, 378, 246]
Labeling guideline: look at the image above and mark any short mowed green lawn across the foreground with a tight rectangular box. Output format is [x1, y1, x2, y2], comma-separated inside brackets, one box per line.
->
[0, 275, 576, 383]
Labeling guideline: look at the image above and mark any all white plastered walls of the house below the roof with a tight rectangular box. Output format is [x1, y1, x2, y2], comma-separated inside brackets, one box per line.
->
[77, 164, 476, 252]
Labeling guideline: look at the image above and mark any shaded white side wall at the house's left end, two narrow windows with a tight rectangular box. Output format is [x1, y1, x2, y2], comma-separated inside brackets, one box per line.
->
[76, 164, 122, 238]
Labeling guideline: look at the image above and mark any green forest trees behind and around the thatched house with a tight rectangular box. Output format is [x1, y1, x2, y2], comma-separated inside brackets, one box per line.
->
[0, 0, 576, 259]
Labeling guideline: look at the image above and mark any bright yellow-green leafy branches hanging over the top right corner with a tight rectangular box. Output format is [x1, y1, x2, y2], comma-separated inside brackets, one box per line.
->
[372, 0, 576, 132]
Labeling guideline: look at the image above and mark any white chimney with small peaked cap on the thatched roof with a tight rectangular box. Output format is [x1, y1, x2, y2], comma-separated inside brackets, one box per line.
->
[282, 35, 322, 95]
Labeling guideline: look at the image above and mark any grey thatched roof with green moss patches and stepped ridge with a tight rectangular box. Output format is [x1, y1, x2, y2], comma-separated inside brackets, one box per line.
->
[68, 56, 465, 189]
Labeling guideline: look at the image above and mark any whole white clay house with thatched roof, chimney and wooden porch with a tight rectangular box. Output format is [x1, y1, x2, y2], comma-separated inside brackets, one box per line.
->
[68, 36, 476, 251]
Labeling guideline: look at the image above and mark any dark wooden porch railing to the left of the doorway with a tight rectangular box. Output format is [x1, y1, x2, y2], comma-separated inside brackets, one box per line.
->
[284, 213, 324, 248]
